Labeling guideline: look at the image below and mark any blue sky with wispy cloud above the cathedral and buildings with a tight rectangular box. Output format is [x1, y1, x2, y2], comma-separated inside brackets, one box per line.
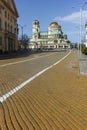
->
[14, 0, 87, 43]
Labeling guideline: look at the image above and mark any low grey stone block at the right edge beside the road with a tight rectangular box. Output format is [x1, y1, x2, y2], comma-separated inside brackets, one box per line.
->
[79, 53, 87, 75]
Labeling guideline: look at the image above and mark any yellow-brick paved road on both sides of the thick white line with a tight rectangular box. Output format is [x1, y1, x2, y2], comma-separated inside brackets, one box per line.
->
[0, 51, 87, 130]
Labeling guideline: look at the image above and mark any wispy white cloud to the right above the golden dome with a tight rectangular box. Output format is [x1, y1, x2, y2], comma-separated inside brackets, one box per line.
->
[54, 10, 87, 24]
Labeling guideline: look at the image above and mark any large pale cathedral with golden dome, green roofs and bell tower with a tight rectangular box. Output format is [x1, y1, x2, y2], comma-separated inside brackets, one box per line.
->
[29, 20, 70, 49]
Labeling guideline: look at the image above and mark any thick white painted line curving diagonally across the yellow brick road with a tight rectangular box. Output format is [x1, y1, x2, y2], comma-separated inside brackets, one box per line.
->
[0, 51, 71, 103]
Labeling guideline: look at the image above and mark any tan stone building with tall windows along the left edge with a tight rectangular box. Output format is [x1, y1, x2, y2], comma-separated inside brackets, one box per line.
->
[0, 0, 18, 53]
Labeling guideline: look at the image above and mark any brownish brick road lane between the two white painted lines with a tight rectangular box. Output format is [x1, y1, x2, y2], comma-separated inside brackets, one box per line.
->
[0, 51, 68, 100]
